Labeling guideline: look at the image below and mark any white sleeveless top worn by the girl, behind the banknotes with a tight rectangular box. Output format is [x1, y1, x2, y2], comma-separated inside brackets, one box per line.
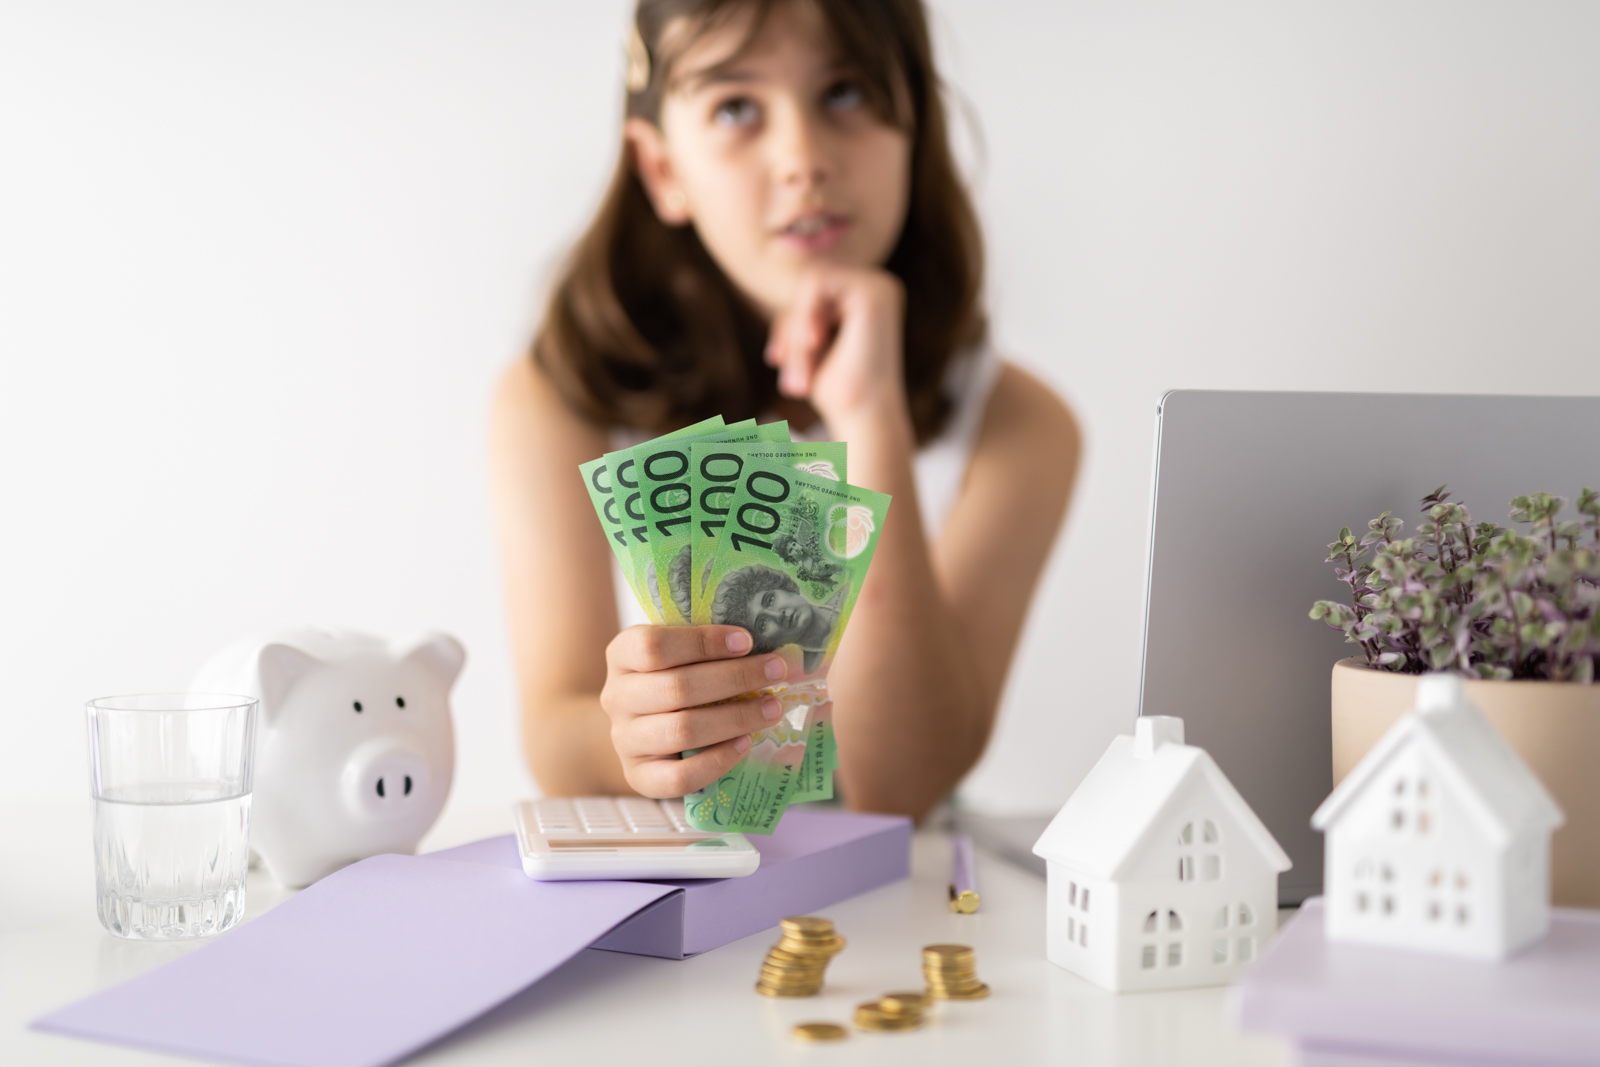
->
[611, 346, 1000, 629]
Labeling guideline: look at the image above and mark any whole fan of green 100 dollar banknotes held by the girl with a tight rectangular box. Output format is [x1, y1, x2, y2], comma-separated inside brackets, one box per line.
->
[579, 416, 890, 833]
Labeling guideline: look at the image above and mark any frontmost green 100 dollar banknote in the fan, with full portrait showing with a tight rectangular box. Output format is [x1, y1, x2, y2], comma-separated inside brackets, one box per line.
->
[685, 459, 890, 833]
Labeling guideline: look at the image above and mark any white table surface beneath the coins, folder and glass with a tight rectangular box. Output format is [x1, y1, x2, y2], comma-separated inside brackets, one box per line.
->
[0, 800, 1288, 1067]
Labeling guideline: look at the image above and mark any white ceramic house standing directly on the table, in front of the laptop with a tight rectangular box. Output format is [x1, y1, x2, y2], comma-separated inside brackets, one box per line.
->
[1034, 717, 1290, 992]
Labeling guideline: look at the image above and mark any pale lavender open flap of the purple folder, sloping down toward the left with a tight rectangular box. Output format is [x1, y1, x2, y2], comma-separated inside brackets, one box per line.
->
[34, 856, 674, 1067]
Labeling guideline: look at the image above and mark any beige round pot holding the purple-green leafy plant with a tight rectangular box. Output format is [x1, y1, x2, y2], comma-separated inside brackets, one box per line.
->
[1333, 657, 1600, 907]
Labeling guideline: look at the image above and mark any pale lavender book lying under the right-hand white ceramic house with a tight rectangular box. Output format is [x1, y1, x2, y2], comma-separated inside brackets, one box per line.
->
[1234, 897, 1600, 1067]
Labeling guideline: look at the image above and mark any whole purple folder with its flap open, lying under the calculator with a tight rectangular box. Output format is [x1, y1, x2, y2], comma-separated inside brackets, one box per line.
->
[34, 809, 910, 1067]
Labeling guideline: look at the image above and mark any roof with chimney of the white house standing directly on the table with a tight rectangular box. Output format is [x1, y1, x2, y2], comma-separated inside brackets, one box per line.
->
[1034, 718, 1291, 878]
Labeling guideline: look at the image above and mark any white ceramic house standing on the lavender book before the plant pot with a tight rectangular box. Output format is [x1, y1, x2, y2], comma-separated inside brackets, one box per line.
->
[1310, 673, 1565, 958]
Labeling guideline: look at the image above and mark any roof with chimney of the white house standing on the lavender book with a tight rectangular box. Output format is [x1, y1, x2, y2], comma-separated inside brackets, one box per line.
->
[1310, 675, 1566, 846]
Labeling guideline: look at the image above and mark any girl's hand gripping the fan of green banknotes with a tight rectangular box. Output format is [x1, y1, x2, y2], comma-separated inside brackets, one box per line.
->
[600, 625, 787, 798]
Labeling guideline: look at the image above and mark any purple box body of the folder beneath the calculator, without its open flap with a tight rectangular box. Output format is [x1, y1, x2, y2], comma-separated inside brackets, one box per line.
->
[432, 806, 912, 960]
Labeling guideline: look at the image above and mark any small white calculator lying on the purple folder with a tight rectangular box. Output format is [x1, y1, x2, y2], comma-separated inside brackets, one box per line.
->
[515, 797, 762, 881]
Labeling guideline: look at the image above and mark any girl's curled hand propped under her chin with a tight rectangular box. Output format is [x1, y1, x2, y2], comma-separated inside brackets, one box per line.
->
[766, 267, 910, 437]
